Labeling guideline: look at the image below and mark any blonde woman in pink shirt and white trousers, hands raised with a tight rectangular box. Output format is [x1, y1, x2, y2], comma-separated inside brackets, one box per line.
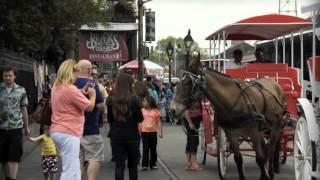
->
[50, 59, 96, 180]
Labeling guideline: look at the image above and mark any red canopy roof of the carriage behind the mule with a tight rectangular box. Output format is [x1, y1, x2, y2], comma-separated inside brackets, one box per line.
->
[206, 14, 312, 40]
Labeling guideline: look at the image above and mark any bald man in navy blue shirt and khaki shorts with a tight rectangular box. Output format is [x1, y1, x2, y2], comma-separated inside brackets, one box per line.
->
[75, 60, 105, 180]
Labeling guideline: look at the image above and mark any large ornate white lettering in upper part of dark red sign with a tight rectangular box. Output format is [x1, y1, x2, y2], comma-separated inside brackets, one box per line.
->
[86, 33, 120, 52]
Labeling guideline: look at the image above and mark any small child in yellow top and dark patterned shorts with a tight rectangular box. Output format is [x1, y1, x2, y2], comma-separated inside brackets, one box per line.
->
[29, 126, 58, 180]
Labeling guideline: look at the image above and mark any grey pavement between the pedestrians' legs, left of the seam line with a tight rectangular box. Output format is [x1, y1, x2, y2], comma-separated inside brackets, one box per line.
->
[17, 124, 170, 180]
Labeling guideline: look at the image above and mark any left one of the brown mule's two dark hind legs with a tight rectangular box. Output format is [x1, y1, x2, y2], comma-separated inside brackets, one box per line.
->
[250, 129, 270, 180]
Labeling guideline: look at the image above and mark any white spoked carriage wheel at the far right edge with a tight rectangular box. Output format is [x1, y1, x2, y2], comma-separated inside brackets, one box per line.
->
[294, 116, 317, 180]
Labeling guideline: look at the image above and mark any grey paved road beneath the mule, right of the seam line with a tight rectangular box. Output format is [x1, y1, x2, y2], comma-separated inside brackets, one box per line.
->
[158, 126, 294, 180]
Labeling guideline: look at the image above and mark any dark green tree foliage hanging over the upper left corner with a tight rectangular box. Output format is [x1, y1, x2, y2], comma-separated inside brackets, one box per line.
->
[0, 0, 107, 55]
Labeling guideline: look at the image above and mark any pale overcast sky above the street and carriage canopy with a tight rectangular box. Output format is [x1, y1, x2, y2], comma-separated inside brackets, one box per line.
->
[146, 0, 320, 48]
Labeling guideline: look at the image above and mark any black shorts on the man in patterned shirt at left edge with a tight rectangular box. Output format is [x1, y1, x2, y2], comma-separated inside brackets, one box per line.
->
[0, 129, 23, 163]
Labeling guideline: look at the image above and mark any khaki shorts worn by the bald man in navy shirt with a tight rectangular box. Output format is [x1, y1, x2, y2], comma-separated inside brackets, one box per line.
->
[80, 134, 104, 162]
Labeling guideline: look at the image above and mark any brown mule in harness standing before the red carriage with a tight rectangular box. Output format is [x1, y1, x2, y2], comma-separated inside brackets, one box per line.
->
[171, 54, 286, 180]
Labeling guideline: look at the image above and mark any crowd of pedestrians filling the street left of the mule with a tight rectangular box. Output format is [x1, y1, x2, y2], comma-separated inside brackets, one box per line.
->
[0, 59, 199, 180]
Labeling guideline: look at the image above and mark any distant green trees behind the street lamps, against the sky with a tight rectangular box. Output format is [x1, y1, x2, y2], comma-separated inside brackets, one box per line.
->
[149, 36, 200, 61]
